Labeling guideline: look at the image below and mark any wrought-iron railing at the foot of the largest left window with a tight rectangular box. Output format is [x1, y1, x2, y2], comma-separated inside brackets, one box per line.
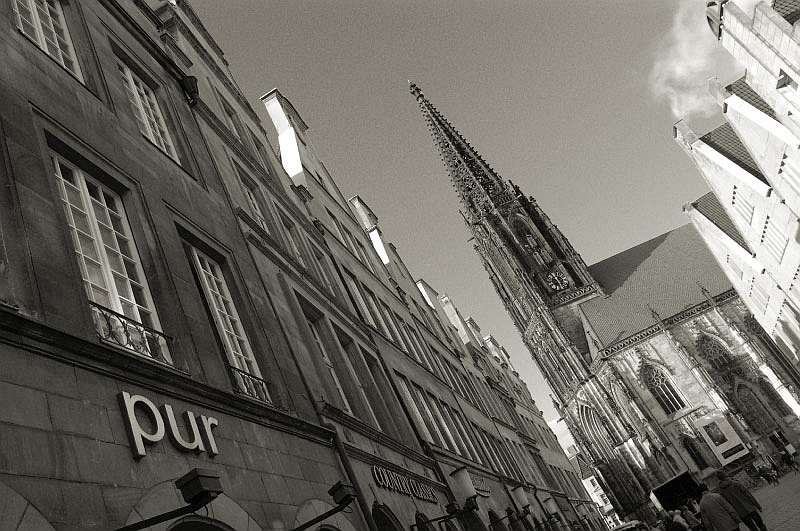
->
[89, 301, 172, 365]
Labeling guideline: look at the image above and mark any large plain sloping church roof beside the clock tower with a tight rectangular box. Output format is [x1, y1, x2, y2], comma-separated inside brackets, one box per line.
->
[580, 225, 732, 348]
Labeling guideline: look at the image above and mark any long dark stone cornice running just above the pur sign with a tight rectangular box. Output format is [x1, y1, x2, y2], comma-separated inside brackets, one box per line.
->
[0, 306, 333, 446]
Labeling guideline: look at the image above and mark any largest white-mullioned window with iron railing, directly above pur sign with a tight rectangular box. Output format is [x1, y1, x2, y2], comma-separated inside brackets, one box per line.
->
[51, 154, 172, 363]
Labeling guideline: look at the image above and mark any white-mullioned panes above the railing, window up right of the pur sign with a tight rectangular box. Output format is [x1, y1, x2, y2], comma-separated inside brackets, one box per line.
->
[191, 247, 261, 386]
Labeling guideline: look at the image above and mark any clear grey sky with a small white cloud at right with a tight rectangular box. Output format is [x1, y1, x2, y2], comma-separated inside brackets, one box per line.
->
[191, 0, 753, 443]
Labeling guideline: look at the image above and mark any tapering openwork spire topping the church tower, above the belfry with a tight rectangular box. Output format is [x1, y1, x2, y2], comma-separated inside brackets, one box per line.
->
[408, 81, 514, 223]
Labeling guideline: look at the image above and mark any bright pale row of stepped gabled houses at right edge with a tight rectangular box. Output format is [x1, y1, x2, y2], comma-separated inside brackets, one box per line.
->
[675, 1, 800, 385]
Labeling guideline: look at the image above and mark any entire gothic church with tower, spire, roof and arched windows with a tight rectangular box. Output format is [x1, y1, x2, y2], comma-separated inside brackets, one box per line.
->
[411, 84, 800, 518]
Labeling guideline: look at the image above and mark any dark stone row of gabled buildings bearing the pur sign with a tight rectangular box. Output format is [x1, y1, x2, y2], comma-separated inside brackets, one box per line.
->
[0, 0, 601, 531]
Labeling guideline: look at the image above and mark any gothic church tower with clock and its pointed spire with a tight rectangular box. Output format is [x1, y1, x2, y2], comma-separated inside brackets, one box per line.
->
[410, 83, 600, 404]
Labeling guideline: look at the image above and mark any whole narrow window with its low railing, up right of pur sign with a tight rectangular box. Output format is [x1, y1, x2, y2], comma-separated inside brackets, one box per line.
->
[191, 247, 270, 402]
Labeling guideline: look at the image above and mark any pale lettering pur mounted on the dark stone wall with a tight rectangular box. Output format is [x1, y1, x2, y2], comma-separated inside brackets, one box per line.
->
[119, 391, 219, 458]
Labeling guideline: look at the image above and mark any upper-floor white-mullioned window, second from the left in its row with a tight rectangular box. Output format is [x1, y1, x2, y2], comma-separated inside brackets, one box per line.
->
[117, 61, 178, 160]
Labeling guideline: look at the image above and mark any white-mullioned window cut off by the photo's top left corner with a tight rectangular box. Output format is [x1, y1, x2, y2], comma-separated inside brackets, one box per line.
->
[14, 0, 83, 81]
